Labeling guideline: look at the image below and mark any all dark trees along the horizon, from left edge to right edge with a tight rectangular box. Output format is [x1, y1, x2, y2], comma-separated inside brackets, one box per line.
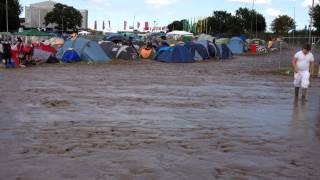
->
[0, 0, 320, 35]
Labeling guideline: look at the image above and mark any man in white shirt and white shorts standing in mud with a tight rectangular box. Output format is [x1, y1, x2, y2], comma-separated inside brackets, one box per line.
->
[292, 44, 314, 101]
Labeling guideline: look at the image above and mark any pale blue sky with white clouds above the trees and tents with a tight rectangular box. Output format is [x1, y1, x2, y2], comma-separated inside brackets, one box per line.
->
[20, 0, 319, 31]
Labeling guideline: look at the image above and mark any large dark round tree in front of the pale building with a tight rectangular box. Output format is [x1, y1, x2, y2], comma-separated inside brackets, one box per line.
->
[44, 3, 82, 31]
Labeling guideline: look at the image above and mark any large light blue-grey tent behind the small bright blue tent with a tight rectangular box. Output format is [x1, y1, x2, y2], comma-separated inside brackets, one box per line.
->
[57, 37, 111, 62]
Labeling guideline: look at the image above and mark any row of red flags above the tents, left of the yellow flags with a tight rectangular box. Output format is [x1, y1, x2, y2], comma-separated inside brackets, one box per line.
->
[94, 20, 166, 31]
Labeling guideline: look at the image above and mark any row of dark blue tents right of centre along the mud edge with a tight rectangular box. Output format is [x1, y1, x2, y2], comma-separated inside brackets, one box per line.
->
[153, 40, 232, 63]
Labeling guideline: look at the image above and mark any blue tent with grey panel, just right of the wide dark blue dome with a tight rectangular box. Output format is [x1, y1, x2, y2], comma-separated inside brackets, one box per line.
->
[184, 42, 209, 61]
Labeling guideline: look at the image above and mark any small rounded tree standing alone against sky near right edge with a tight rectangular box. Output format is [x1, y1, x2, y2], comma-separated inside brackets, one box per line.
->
[271, 15, 296, 35]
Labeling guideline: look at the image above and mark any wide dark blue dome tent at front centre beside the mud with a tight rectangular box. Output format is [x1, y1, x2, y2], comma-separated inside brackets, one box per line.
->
[154, 45, 195, 63]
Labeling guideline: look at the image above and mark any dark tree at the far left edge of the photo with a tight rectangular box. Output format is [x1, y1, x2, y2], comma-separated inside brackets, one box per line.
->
[0, 0, 22, 31]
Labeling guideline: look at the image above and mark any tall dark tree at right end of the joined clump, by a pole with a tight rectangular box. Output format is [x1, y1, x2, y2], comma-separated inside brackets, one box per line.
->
[236, 8, 267, 33]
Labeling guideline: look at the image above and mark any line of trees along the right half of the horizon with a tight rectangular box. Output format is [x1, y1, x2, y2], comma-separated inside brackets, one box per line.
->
[168, 5, 320, 36]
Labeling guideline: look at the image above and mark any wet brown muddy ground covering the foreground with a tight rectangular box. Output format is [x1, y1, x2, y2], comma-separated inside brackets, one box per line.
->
[0, 48, 320, 180]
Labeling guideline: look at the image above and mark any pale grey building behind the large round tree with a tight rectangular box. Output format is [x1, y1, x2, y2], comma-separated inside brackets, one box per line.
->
[24, 0, 88, 29]
